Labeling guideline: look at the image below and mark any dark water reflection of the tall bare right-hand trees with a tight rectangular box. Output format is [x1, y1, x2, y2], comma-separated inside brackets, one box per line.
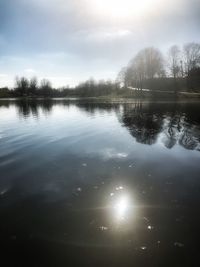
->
[121, 103, 200, 150]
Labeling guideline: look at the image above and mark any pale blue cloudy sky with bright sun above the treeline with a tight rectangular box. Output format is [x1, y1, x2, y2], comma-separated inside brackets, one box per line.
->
[0, 0, 200, 87]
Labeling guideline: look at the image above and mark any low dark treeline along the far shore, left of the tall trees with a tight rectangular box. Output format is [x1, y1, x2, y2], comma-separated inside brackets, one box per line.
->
[0, 77, 122, 98]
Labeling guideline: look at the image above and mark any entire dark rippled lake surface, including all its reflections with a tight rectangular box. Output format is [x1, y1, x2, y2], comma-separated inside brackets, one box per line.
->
[0, 100, 200, 267]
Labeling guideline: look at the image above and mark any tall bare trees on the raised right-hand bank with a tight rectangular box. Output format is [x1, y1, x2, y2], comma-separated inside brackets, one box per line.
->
[117, 43, 200, 92]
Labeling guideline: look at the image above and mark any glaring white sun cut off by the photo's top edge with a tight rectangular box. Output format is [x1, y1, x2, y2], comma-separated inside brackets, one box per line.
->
[90, 0, 157, 19]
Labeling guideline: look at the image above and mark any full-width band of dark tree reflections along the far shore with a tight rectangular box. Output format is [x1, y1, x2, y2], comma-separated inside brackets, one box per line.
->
[0, 99, 200, 150]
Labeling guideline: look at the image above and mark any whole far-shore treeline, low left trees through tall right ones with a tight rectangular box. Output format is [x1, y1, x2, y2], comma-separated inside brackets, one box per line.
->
[0, 43, 200, 98]
